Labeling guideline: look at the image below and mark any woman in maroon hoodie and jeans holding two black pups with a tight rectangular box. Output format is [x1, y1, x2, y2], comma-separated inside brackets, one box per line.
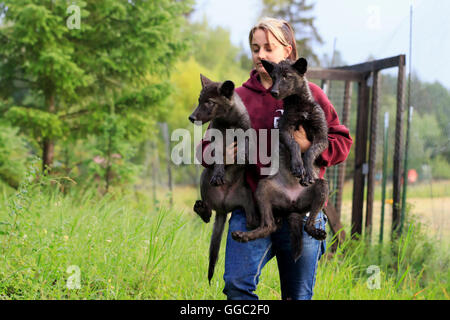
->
[202, 18, 352, 300]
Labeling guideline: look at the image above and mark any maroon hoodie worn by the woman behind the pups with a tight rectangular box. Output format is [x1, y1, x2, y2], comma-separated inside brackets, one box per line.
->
[197, 69, 353, 192]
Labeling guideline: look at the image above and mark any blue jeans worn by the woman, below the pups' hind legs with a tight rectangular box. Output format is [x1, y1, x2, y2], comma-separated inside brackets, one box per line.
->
[223, 210, 327, 300]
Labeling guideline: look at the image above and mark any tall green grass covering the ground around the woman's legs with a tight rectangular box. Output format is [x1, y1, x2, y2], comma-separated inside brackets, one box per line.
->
[0, 178, 450, 300]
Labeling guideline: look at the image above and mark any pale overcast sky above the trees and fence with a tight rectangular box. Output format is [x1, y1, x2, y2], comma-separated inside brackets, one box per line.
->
[193, 0, 450, 89]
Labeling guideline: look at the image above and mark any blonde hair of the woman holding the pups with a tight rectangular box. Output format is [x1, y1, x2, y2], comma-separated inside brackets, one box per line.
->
[248, 17, 298, 61]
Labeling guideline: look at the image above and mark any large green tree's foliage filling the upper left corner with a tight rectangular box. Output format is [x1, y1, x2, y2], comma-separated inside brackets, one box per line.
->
[0, 0, 190, 170]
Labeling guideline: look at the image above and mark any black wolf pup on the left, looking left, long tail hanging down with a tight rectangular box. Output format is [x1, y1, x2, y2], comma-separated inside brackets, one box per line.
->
[189, 75, 258, 282]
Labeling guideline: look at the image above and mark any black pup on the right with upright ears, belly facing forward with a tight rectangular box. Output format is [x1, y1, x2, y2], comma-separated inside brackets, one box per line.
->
[232, 58, 328, 260]
